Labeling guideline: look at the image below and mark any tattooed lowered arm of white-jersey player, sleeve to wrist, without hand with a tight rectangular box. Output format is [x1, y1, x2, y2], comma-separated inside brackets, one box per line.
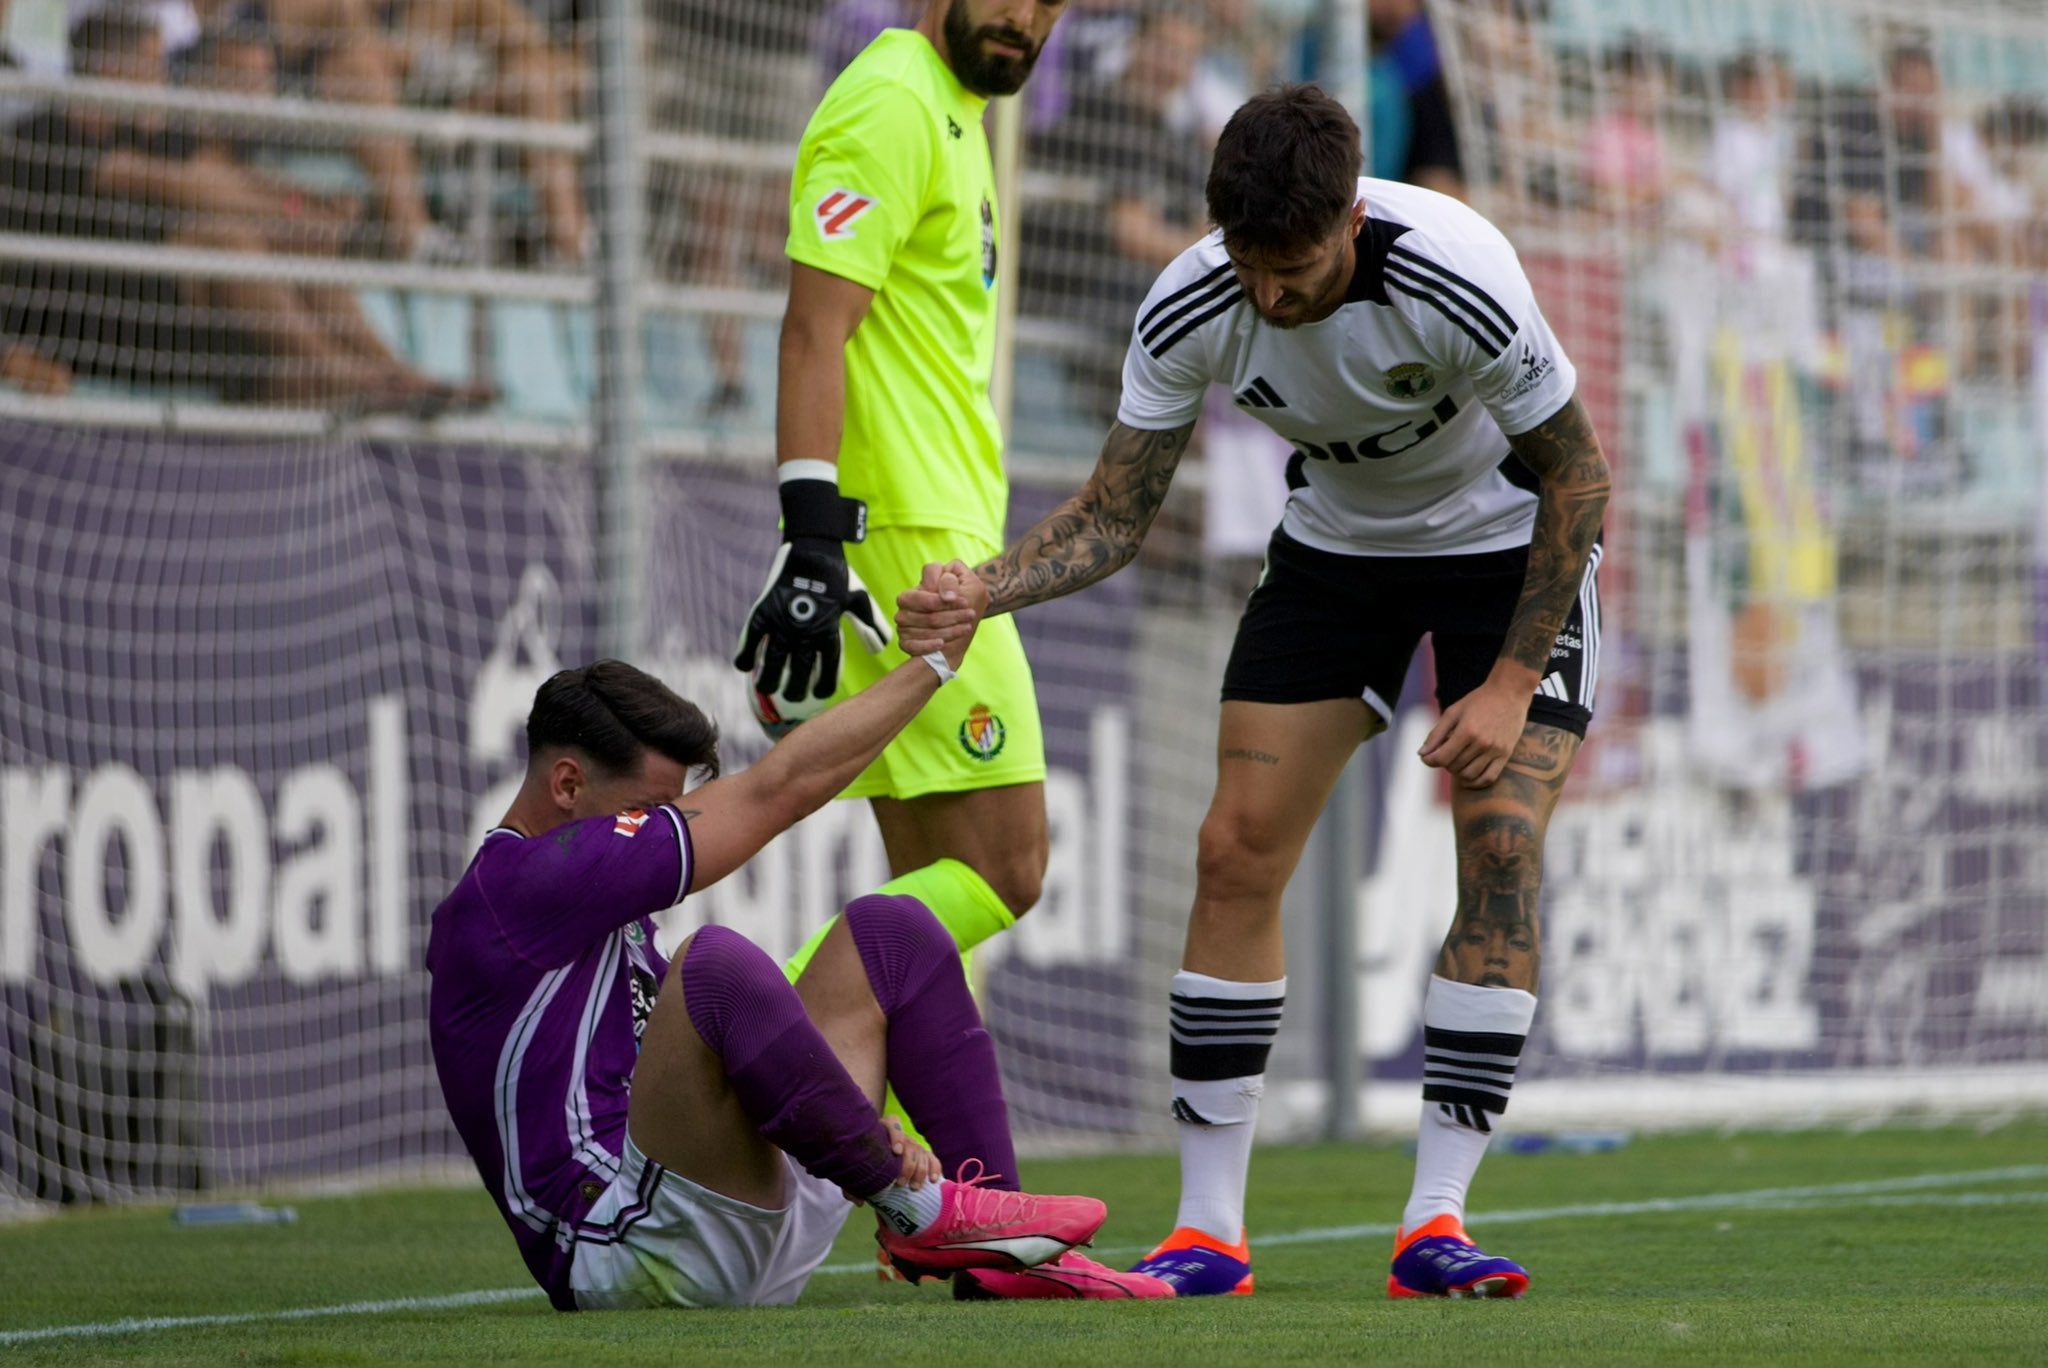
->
[1501, 395, 1610, 674]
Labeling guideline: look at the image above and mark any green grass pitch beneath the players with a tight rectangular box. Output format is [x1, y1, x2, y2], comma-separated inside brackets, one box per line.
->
[0, 1120, 2048, 1368]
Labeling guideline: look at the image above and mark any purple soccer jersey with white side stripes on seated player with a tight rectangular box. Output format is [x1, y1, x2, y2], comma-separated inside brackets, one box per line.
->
[426, 805, 690, 1311]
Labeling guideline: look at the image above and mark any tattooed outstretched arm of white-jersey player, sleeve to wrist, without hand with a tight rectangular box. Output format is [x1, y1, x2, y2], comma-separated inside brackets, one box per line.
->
[975, 422, 1194, 612]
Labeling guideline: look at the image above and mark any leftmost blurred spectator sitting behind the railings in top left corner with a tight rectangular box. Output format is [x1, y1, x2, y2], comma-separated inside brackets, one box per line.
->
[0, 10, 483, 414]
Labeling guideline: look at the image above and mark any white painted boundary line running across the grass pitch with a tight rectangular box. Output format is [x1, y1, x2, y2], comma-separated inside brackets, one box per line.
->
[0, 1163, 2048, 1345]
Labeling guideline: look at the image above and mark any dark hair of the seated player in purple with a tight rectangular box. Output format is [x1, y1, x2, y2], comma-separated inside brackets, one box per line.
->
[526, 659, 719, 778]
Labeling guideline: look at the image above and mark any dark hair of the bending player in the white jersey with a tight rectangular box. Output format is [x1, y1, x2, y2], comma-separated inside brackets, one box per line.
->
[1208, 84, 1360, 252]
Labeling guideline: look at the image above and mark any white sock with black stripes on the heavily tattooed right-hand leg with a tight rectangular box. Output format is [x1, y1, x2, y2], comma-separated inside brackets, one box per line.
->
[1401, 975, 1536, 1231]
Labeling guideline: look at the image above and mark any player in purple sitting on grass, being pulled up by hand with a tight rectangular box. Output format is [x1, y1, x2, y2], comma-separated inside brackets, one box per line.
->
[426, 565, 1167, 1311]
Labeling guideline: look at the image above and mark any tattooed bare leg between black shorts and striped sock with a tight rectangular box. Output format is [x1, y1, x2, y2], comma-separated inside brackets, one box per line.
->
[1436, 723, 1579, 993]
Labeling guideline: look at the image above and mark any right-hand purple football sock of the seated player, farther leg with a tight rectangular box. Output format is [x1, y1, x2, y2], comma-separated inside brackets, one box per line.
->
[846, 893, 1018, 1192]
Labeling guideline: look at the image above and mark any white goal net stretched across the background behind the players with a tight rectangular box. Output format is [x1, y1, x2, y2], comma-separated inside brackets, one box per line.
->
[12, 0, 2048, 1204]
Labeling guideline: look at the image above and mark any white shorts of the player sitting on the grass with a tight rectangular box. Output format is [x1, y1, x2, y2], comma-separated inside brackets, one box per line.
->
[569, 1135, 854, 1311]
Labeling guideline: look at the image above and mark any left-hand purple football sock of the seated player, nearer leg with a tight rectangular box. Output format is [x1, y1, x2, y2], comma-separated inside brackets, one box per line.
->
[682, 926, 903, 1198]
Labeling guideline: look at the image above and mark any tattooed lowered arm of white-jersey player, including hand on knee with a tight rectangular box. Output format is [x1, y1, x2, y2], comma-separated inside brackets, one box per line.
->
[1421, 395, 1610, 788]
